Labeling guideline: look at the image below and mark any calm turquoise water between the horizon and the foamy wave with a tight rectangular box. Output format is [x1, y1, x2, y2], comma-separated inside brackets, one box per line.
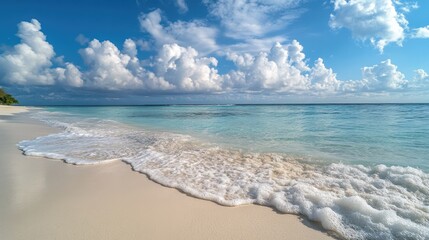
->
[41, 104, 429, 170]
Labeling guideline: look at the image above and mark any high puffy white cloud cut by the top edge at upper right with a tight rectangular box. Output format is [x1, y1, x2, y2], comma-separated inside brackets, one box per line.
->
[329, 0, 408, 52]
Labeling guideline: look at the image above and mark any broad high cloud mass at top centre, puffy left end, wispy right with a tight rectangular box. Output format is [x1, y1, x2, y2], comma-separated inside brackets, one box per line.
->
[139, 3, 304, 55]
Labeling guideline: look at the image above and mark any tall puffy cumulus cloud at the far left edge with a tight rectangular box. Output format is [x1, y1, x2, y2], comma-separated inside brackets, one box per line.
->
[0, 19, 83, 86]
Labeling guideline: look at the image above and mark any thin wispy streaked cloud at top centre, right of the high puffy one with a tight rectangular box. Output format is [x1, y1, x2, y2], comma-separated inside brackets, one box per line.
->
[203, 0, 306, 55]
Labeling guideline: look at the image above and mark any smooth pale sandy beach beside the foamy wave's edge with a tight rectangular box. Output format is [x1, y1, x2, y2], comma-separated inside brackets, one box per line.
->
[0, 106, 331, 239]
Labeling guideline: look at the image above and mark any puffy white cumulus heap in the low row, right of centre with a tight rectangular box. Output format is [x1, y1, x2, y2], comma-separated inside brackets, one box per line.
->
[223, 40, 408, 95]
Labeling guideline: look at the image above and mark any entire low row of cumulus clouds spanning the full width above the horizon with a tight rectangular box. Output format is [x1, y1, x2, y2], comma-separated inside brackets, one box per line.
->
[0, 17, 422, 96]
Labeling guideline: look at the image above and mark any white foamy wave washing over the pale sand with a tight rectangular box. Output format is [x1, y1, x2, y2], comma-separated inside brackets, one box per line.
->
[19, 111, 429, 239]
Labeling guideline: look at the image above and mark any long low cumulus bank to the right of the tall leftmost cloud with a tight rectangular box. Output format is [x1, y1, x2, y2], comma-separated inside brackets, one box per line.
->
[73, 39, 412, 95]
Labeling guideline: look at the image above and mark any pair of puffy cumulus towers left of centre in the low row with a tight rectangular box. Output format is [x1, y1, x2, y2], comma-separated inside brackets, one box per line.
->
[80, 39, 221, 93]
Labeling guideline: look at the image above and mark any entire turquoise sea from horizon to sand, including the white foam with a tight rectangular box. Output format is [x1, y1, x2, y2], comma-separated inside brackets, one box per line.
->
[18, 104, 429, 239]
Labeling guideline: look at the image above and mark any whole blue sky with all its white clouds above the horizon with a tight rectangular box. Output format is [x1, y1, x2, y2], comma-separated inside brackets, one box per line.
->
[0, 0, 429, 105]
